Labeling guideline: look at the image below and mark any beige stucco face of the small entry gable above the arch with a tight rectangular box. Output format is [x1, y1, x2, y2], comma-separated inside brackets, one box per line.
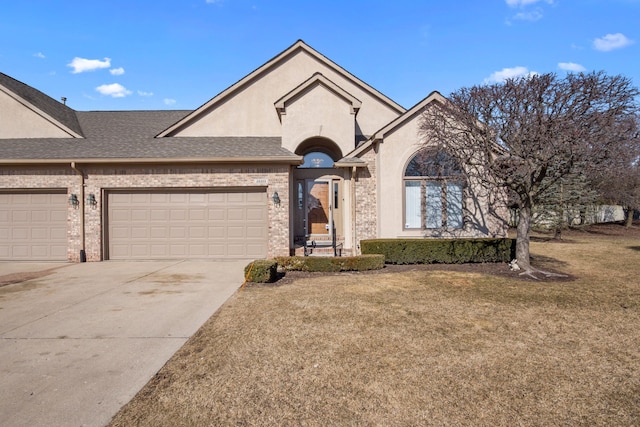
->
[282, 85, 355, 155]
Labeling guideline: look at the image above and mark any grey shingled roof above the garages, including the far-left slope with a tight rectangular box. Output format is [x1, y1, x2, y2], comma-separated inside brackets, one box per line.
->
[0, 74, 301, 164]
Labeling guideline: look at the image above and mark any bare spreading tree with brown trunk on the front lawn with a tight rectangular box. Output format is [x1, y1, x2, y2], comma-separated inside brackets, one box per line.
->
[421, 72, 639, 277]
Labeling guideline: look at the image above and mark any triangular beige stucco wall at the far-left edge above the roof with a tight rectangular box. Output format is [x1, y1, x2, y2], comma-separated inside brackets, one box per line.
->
[0, 90, 70, 138]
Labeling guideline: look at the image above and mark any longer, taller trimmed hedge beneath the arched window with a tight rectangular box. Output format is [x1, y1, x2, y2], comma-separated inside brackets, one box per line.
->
[360, 239, 516, 264]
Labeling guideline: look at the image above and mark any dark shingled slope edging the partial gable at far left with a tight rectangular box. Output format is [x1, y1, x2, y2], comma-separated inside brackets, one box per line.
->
[0, 73, 82, 135]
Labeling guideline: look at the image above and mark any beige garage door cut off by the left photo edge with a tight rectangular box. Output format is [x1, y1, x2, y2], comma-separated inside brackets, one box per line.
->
[0, 191, 67, 261]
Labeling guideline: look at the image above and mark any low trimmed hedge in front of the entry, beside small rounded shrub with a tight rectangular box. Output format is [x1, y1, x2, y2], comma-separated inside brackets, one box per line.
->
[275, 254, 384, 272]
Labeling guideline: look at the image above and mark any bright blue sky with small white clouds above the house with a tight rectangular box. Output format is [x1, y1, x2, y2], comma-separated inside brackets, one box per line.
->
[0, 0, 640, 111]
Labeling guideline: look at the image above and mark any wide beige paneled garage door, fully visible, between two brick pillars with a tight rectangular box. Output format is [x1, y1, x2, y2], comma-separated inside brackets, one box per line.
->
[107, 190, 267, 259]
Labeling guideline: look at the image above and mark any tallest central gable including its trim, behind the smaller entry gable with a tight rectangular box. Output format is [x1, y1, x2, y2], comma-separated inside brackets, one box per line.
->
[159, 41, 404, 136]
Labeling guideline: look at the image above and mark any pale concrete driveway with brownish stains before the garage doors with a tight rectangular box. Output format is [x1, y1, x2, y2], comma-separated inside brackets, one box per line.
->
[0, 261, 248, 427]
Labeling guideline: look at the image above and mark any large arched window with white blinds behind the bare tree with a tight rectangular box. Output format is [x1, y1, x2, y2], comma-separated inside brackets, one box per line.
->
[404, 149, 464, 229]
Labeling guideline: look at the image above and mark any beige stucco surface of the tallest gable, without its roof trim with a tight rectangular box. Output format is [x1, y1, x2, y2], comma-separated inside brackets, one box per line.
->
[170, 49, 398, 142]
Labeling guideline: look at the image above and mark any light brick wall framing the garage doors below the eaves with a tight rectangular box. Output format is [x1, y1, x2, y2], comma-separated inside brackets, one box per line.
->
[0, 165, 290, 262]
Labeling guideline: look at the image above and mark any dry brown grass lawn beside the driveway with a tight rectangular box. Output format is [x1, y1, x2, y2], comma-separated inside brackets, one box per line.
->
[112, 224, 640, 426]
